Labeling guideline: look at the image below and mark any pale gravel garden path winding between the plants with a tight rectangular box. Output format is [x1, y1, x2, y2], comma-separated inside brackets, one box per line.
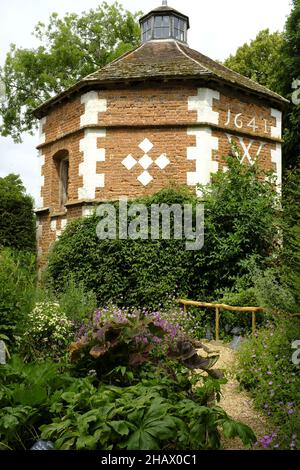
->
[199, 341, 269, 450]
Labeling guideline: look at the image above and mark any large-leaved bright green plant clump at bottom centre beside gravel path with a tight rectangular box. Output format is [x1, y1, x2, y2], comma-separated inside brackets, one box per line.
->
[41, 374, 255, 450]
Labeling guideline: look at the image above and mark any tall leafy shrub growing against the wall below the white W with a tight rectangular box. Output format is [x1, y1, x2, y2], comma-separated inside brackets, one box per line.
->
[191, 157, 280, 300]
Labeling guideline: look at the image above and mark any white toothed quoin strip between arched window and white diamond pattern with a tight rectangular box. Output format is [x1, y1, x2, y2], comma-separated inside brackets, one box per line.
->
[78, 129, 106, 199]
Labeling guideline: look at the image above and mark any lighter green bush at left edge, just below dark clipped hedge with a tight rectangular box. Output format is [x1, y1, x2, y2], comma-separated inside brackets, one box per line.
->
[0, 248, 35, 340]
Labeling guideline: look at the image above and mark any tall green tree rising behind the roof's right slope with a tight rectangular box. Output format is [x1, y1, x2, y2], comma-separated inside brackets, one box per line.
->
[225, 5, 300, 168]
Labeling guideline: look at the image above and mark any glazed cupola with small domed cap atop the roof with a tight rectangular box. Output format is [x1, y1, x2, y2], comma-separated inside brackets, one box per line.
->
[140, 0, 190, 44]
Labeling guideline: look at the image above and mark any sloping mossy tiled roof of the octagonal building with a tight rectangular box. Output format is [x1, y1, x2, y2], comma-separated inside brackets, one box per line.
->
[35, 40, 287, 117]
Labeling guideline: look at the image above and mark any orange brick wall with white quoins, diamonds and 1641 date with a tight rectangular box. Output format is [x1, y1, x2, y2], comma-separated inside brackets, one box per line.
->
[38, 83, 281, 264]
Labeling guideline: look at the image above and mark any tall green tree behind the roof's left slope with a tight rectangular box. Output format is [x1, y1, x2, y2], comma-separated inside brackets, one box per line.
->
[0, 2, 141, 142]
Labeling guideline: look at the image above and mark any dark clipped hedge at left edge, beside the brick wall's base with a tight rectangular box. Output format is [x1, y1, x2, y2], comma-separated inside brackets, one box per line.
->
[0, 174, 36, 252]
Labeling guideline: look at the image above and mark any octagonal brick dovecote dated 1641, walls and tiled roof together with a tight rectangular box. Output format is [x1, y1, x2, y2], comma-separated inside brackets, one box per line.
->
[35, 6, 286, 265]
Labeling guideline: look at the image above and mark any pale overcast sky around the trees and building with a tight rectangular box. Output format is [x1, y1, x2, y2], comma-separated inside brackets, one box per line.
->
[0, 0, 291, 203]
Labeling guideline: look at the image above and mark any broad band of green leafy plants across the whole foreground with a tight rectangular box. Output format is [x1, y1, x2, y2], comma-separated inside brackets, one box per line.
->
[0, 357, 255, 450]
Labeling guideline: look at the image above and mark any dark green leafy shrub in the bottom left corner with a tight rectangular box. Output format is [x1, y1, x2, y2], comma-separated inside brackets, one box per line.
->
[0, 356, 71, 450]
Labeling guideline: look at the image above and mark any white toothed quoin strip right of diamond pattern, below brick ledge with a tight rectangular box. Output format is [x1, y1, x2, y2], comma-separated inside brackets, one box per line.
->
[187, 127, 219, 190]
